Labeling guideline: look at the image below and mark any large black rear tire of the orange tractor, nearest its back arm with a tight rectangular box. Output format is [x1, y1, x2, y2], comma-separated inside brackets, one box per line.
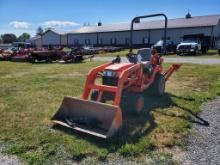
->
[152, 74, 165, 96]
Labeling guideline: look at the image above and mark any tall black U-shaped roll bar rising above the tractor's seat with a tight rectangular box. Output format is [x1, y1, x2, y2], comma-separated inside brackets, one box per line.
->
[130, 13, 168, 54]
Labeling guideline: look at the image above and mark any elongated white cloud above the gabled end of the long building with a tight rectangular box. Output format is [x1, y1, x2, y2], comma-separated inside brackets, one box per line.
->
[43, 20, 80, 28]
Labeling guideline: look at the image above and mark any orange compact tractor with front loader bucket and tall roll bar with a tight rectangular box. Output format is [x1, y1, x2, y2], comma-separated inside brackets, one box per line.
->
[52, 14, 181, 138]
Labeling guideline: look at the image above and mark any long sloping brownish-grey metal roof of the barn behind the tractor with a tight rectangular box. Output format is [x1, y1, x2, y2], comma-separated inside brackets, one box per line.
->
[70, 15, 220, 34]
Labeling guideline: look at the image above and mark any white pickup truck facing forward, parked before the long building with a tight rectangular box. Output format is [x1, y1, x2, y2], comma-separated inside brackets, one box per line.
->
[176, 39, 202, 55]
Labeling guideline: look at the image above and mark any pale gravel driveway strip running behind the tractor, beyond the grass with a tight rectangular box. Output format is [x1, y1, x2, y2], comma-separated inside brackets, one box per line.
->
[94, 57, 220, 65]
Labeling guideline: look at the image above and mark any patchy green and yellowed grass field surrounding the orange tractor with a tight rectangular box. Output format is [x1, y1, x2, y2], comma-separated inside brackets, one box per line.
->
[0, 62, 220, 164]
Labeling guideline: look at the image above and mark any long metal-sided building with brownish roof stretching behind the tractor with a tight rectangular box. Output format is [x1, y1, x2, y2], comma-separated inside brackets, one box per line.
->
[28, 13, 220, 47]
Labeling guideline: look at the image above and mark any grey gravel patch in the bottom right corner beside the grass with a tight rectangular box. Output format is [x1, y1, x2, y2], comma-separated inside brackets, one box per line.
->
[183, 97, 220, 165]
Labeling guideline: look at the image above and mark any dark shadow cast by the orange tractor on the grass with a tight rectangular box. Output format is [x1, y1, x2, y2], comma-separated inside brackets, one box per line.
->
[53, 93, 209, 153]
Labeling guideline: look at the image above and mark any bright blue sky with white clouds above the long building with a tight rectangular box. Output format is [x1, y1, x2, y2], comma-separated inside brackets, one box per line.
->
[0, 0, 220, 36]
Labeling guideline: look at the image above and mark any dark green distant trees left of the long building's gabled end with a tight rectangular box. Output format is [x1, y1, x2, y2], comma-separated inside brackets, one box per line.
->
[0, 26, 46, 44]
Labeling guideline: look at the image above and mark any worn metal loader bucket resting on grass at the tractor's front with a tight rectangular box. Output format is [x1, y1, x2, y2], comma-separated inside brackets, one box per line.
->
[52, 97, 122, 138]
